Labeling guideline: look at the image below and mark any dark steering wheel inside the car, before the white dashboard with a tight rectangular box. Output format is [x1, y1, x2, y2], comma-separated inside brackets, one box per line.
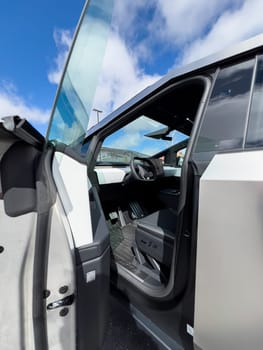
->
[130, 157, 157, 181]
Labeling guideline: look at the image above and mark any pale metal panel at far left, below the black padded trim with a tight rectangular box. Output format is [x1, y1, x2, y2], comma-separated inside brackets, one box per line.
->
[0, 200, 37, 350]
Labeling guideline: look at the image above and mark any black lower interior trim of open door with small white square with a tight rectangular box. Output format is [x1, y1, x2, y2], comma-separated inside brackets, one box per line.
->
[76, 187, 110, 350]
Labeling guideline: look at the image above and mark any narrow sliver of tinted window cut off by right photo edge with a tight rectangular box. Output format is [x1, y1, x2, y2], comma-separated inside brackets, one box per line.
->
[246, 57, 263, 147]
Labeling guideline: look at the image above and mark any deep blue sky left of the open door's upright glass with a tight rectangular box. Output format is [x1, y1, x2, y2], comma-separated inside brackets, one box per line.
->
[0, 0, 84, 134]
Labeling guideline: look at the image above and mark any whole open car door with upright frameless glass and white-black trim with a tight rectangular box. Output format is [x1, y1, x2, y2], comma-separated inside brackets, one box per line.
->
[0, 0, 113, 350]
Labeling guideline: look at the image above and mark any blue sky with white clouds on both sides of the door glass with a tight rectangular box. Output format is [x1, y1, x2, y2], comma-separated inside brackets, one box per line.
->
[0, 0, 263, 137]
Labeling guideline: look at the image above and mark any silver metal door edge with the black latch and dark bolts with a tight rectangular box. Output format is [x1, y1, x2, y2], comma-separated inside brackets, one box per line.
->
[45, 196, 76, 350]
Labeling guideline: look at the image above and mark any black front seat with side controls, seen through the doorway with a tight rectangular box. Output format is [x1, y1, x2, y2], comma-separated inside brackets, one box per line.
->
[135, 209, 177, 266]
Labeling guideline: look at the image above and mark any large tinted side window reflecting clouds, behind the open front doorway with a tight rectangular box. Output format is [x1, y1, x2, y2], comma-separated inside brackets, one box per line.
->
[196, 59, 254, 154]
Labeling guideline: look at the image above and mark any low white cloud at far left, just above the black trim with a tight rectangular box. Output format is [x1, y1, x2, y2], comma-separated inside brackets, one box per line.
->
[0, 82, 50, 124]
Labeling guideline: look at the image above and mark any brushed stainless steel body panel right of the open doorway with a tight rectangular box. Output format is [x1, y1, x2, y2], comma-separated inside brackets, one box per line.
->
[194, 151, 263, 350]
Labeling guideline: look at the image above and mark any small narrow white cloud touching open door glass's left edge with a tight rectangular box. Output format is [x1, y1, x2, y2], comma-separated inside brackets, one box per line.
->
[48, 29, 72, 84]
